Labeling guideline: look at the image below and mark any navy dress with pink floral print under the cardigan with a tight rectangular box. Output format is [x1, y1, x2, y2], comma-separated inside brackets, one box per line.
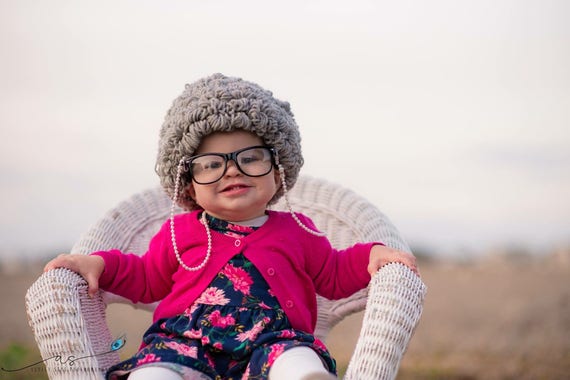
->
[107, 215, 336, 380]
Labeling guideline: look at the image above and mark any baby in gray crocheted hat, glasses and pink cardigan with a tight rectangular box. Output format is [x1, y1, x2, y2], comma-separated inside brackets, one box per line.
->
[45, 74, 417, 380]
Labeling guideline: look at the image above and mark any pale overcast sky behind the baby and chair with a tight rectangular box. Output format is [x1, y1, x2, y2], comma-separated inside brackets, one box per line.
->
[0, 0, 570, 256]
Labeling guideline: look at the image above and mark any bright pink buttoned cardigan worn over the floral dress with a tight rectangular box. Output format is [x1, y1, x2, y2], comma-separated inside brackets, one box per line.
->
[93, 211, 379, 333]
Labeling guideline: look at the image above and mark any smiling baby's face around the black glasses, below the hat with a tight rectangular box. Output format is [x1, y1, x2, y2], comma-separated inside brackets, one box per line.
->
[188, 130, 280, 222]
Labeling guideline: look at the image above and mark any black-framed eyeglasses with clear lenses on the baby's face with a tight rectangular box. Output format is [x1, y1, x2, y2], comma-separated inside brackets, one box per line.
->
[184, 145, 277, 185]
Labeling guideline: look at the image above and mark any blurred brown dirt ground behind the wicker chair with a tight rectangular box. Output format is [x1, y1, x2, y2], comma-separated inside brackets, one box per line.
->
[0, 253, 570, 380]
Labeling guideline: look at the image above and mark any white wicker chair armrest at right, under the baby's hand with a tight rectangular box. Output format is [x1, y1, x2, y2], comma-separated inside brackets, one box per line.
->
[344, 263, 427, 380]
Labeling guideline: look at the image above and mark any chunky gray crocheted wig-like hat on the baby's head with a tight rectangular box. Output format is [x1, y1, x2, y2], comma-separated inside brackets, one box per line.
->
[156, 74, 303, 210]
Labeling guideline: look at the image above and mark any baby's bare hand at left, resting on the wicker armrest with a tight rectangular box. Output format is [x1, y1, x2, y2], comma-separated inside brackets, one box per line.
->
[44, 254, 105, 297]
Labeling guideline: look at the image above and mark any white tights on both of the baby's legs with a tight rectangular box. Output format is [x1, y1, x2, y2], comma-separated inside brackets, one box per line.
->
[129, 347, 336, 380]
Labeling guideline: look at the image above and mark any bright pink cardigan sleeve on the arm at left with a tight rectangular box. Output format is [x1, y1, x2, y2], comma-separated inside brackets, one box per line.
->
[92, 222, 177, 303]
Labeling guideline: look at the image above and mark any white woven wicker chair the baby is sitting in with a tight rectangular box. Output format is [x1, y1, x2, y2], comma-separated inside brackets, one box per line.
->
[26, 177, 426, 380]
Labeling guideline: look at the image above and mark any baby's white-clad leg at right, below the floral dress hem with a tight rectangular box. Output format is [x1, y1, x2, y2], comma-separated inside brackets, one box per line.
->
[269, 347, 336, 380]
